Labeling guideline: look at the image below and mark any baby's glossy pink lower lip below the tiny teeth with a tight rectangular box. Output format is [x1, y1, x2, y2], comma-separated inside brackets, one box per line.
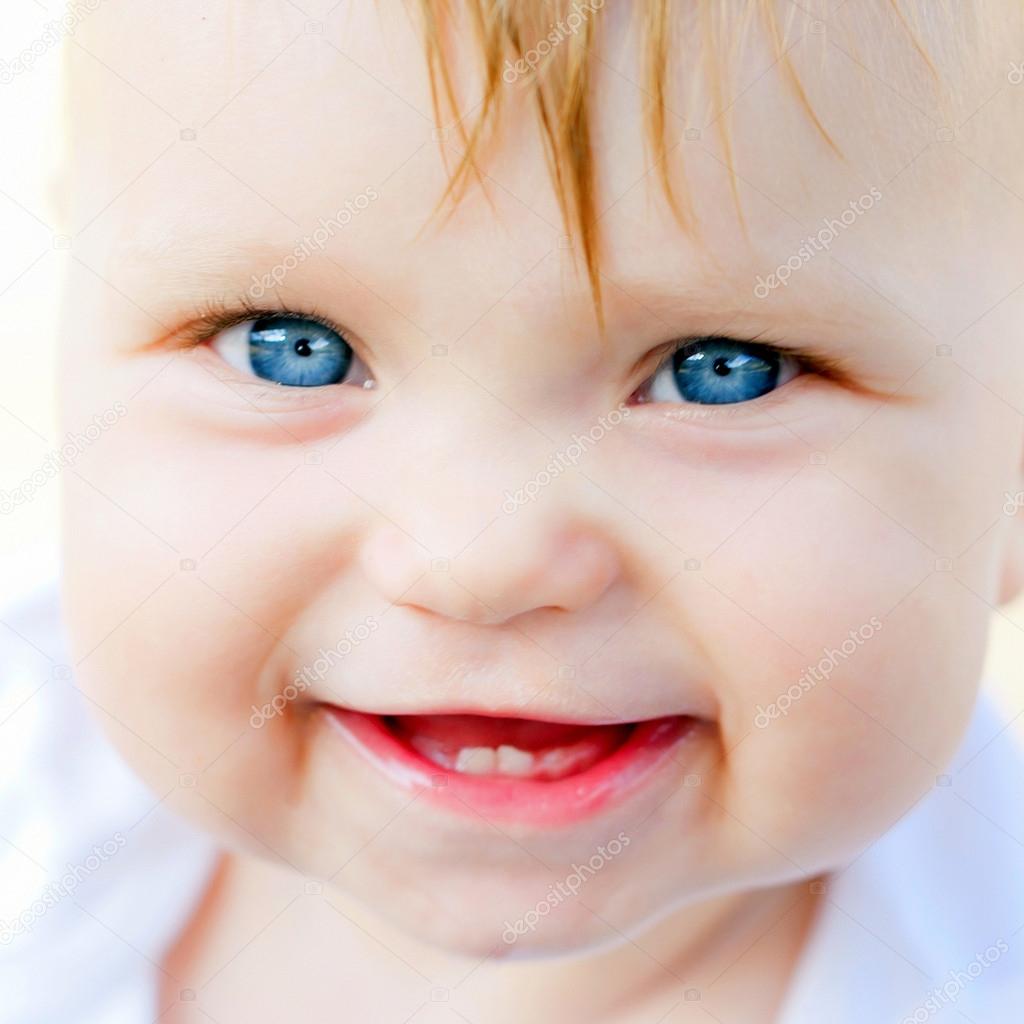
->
[324, 705, 698, 825]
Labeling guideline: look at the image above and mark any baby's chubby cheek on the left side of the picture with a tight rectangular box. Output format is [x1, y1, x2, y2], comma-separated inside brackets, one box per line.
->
[63, 364, 374, 852]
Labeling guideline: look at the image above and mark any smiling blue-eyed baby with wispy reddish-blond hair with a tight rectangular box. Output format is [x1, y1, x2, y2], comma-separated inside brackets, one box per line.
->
[12, 0, 1024, 1024]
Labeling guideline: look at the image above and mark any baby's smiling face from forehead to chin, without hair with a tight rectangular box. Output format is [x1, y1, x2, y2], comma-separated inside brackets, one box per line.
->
[62, 3, 1024, 952]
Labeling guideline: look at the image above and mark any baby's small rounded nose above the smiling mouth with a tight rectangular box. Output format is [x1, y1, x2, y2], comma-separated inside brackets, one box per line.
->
[352, 399, 620, 624]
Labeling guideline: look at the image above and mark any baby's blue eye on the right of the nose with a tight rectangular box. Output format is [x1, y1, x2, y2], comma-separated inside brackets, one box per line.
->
[648, 338, 799, 406]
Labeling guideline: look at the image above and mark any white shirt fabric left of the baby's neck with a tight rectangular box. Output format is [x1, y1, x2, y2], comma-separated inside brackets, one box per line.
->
[0, 569, 216, 1024]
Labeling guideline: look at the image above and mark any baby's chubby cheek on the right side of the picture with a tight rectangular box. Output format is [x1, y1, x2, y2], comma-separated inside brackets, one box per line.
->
[690, 467, 994, 871]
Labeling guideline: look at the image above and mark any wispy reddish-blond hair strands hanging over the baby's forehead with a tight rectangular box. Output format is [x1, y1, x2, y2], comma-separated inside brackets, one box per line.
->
[415, 0, 978, 318]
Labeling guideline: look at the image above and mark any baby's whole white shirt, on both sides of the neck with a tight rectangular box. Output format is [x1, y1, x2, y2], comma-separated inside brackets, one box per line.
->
[0, 581, 1024, 1024]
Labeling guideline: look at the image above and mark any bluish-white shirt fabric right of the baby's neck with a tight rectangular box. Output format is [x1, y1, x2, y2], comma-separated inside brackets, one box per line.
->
[778, 699, 1024, 1024]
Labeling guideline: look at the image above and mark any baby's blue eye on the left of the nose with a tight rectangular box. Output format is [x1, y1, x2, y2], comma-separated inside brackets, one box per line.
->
[212, 315, 353, 387]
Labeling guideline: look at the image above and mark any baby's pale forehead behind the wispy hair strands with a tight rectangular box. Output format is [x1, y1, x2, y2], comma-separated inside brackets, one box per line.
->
[69, 2, 1024, 339]
